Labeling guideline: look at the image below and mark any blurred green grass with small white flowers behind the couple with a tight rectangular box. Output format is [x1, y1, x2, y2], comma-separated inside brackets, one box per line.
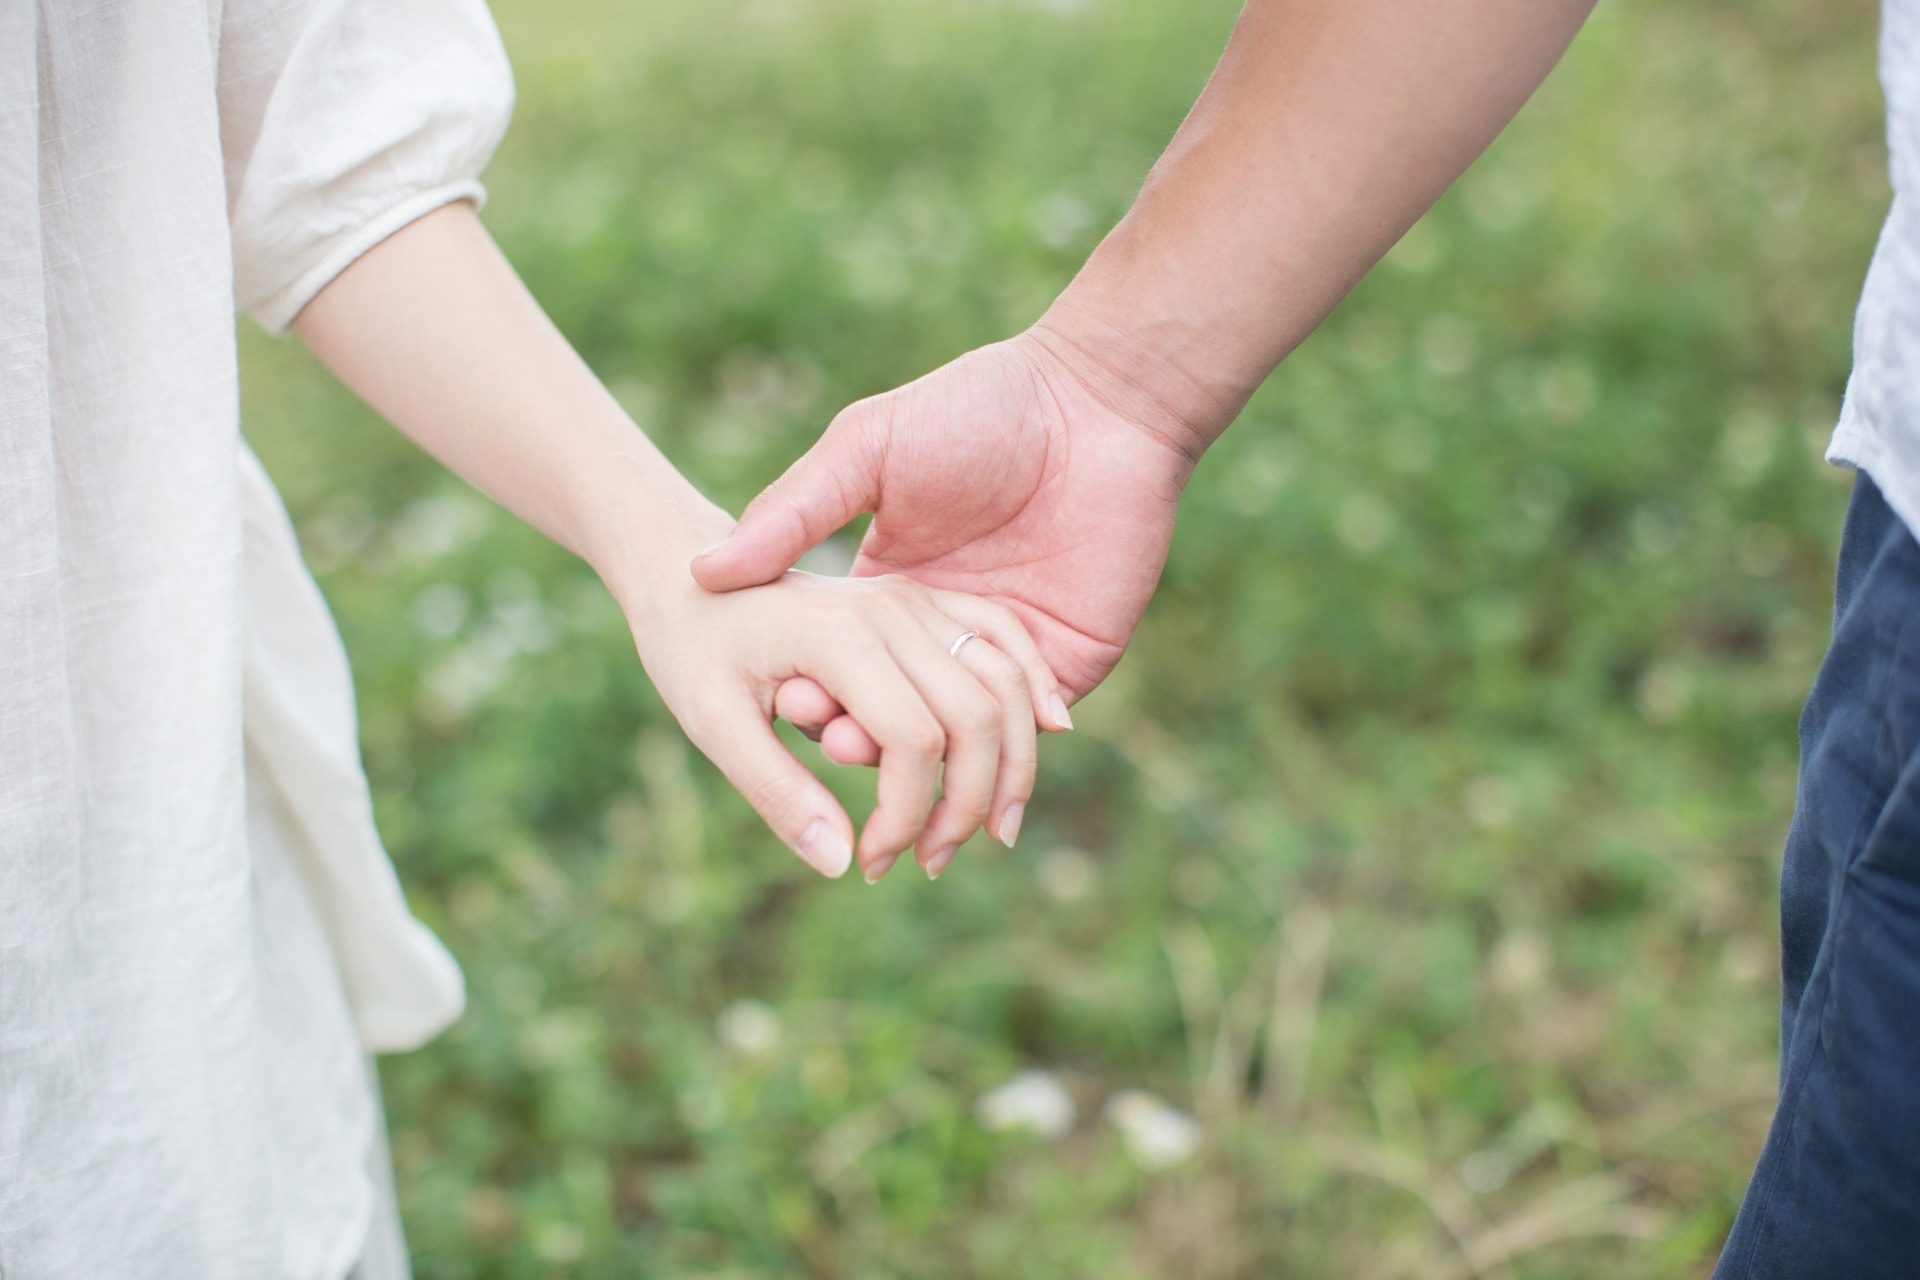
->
[246, 0, 1885, 1280]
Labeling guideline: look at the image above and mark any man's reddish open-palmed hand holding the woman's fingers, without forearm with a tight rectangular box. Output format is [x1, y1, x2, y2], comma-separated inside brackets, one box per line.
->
[693, 328, 1194, 762]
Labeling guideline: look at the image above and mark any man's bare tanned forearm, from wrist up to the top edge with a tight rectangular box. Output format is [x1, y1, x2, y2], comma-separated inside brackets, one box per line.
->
[1035, 0, 1594, 455]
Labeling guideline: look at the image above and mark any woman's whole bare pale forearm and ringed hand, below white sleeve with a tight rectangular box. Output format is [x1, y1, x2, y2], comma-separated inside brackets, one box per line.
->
[294, 203, 1060, 881]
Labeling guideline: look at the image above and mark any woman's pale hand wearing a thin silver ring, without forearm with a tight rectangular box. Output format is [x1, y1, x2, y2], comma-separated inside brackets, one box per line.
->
[616, 537, 1054, 881]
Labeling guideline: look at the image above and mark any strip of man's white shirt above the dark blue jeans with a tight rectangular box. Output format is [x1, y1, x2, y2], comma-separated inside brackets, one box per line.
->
[1826, 0, 1920, 532]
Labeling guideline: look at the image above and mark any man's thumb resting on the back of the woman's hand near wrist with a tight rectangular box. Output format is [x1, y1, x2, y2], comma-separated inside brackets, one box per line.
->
[693, 409, 879, 591]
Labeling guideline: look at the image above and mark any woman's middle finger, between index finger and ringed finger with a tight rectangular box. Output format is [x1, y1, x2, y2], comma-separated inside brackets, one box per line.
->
[881, 603, 1006, 865]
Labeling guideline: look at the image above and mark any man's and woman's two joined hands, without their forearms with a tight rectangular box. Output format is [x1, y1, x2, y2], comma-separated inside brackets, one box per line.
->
[603, 326, 1198, 881]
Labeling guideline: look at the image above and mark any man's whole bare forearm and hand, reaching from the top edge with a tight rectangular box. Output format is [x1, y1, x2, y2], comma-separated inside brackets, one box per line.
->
[693, 0, 1592, 762]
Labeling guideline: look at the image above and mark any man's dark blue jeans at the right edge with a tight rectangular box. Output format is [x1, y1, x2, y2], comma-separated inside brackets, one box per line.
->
[1713, 474, 1920, 1280]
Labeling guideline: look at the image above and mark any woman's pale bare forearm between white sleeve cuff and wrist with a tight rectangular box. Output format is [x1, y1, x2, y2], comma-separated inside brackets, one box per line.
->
[294, 203, 732, 614]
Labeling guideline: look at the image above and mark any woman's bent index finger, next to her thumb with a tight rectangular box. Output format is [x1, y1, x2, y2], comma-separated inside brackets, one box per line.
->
[804, 633, 947, 879]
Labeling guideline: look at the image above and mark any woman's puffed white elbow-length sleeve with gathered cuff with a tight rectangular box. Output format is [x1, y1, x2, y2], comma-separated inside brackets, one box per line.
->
[219, 0, 513, 332]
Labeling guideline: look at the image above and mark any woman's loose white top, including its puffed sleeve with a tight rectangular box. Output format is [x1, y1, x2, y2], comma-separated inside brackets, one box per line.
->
[0, 0, 513, 1280]
